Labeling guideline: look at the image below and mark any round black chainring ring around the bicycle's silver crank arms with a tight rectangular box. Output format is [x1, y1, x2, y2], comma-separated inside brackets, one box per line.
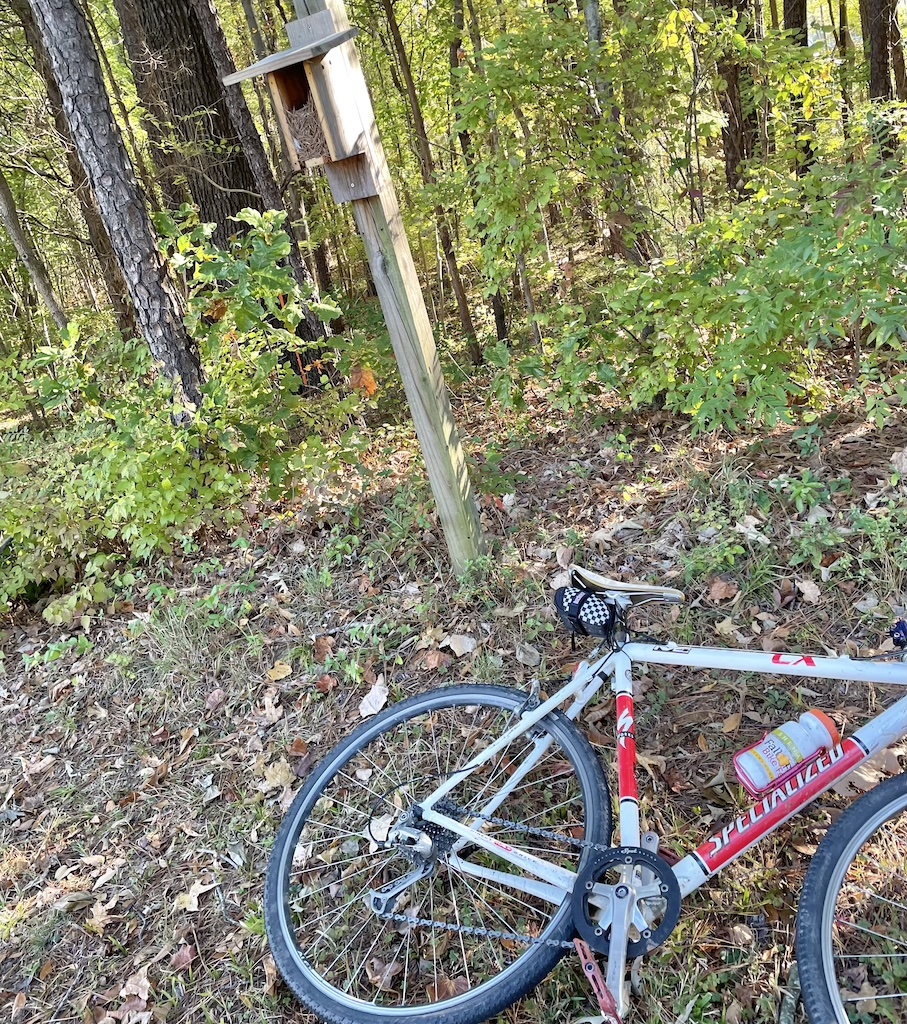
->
[571, 846, 682, 958]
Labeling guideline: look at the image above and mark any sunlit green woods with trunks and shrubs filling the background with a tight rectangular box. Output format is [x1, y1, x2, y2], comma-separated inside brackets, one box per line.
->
[0, 0, 907, 621]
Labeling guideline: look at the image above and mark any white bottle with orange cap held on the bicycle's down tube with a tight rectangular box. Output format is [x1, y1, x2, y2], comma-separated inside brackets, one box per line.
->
[734, 708, 840, 797]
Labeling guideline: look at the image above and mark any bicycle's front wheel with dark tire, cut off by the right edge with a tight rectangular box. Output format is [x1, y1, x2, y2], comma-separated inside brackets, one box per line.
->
[796, 775, 907, 1024]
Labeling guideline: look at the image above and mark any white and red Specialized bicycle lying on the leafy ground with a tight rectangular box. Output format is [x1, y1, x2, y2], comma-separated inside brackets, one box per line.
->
[265, 566, 907, 1024]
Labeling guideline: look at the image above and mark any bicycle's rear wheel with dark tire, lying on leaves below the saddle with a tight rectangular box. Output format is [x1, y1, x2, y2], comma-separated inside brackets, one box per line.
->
[264, 685, 611, 1024]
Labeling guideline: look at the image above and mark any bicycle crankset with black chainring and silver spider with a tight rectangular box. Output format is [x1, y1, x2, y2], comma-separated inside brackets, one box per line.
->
[571, 846, 682, 959]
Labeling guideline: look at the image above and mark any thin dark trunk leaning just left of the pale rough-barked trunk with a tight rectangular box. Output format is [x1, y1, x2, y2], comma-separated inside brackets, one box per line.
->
[11, 0, 138, 337]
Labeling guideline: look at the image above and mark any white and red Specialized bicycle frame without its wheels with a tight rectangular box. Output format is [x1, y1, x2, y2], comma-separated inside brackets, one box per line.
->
[409, 630, 907, 1014]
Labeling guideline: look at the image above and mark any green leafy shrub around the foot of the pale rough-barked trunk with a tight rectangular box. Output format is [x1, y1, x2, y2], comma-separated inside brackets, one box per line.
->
[0, 203, 357, 621]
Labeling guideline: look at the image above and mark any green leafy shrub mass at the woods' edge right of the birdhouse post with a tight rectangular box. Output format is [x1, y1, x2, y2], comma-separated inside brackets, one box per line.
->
[489, 158, 907, 430]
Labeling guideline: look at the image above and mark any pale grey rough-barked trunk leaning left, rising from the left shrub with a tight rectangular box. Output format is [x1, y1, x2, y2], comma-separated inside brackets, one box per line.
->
[29, 0, 202, 404]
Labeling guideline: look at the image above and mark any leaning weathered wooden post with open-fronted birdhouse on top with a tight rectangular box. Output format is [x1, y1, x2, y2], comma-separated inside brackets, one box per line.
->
[224, 0, 484, 574]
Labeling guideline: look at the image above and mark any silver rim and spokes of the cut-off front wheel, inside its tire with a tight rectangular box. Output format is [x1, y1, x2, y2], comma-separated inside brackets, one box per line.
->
[822, 799, 907, 1024]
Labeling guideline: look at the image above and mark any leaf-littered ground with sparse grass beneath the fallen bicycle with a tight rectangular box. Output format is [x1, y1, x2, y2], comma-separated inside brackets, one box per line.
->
[0, 387, 907, 1024]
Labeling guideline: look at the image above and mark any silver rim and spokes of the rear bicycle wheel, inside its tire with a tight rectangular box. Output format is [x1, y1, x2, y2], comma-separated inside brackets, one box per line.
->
[273, 694, 601, 1018]
